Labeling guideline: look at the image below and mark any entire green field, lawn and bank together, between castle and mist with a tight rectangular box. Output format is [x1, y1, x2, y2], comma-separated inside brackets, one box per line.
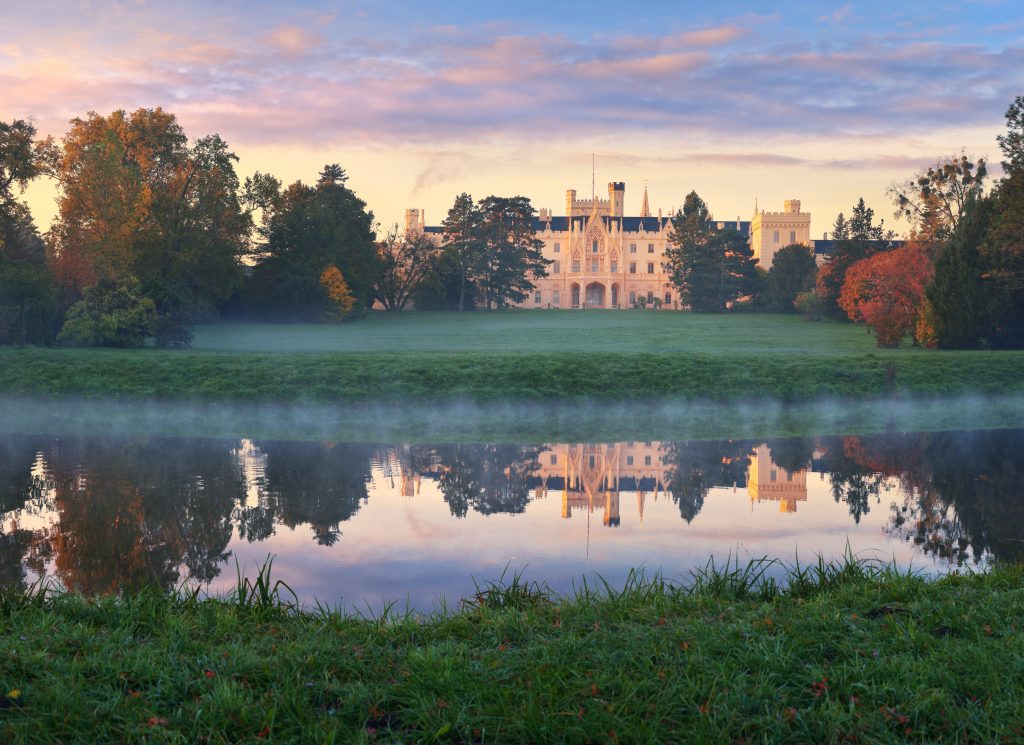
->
[0, 311, 1024, 403]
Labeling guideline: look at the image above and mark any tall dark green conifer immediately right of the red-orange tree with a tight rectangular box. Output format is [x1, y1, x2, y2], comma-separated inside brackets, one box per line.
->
[926, 198, 992, 349]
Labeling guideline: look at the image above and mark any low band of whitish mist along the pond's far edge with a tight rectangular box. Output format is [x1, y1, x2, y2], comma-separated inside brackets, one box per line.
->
[0, 395, 1024, 442]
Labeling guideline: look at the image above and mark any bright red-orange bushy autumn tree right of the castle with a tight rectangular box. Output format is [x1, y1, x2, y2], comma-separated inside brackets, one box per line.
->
[840, 243, 932, 347]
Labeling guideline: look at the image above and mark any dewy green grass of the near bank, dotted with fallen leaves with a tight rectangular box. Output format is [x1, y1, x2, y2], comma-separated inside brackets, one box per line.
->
[0, 561, 1024, 743]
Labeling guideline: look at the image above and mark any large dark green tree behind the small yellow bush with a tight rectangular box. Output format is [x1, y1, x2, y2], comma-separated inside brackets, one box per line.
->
[247, 165, 380, 321]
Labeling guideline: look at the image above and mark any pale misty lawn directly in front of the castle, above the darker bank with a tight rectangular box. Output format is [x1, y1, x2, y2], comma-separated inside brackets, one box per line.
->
[193, 310, 897, 356]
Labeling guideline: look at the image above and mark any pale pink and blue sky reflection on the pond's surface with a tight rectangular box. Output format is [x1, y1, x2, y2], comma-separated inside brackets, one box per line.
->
[213, 448, 938, 609]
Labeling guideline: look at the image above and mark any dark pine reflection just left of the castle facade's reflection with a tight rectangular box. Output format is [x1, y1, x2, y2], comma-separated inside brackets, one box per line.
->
[434, 445, 541, 518]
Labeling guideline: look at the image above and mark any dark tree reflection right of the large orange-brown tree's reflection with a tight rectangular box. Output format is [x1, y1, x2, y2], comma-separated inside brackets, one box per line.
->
[249, 442, 377, 545]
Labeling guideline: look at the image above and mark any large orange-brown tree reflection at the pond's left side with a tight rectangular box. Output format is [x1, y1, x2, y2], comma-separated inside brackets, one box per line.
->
[35, 439, 242, 595]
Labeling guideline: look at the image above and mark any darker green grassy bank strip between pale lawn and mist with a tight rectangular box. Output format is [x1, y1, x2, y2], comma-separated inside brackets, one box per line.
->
[0, 349, 1024, 403]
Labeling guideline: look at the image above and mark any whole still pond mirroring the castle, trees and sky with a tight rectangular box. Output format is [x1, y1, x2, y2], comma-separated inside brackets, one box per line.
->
[0, 430, 1024, 611]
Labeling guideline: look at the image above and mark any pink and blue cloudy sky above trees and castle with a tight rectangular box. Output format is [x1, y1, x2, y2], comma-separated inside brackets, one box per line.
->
[0, 0, 1024, 237]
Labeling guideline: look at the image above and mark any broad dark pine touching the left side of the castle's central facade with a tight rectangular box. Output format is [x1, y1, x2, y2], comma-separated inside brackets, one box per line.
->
[472, 196, 551, 308]
